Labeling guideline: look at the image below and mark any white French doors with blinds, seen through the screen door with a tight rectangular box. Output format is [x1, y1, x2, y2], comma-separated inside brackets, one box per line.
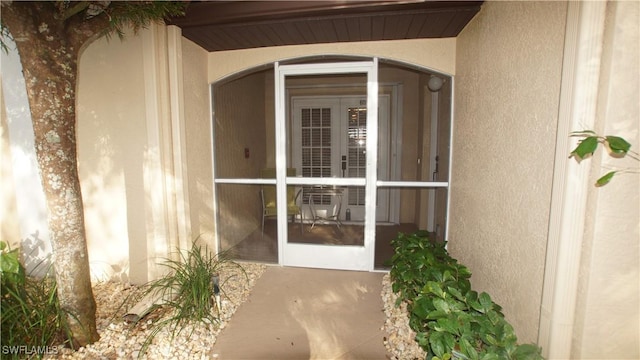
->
[290, 96, 389, 223]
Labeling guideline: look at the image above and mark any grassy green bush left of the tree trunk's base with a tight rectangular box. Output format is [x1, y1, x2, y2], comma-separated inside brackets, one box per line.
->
[0, 241, 70, 359]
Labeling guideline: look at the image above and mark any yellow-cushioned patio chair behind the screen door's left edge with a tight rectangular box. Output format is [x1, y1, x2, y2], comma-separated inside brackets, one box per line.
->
[260, 168, 302, 237]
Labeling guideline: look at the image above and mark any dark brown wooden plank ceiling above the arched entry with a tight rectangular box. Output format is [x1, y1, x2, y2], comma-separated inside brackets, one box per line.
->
[167, 0, 482, 51]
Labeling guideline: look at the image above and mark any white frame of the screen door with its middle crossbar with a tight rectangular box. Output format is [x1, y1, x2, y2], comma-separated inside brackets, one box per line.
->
[274, 58, 378, 271]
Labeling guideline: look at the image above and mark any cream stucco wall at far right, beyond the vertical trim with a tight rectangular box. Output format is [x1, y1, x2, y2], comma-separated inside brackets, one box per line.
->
[572, 1, 640, 359]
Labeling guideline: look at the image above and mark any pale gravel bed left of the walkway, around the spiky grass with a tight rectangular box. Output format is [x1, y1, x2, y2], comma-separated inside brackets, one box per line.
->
[45, 263, 266, 360]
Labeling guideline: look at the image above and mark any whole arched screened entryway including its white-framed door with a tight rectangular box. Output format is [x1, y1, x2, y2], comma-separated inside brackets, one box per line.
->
[211, 57, 452, 270]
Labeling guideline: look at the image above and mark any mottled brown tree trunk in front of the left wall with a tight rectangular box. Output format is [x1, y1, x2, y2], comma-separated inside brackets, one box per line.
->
[2, 2, 99, 347]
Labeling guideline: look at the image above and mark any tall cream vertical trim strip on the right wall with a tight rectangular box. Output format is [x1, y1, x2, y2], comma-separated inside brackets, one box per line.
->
[538, 1, 607, 359]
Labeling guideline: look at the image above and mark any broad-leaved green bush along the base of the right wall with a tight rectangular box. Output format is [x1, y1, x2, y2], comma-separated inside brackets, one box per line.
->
[390, 232, 542, 360]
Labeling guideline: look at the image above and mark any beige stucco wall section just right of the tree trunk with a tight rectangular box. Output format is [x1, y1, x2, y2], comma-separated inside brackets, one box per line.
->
[77, 31, 147, 279]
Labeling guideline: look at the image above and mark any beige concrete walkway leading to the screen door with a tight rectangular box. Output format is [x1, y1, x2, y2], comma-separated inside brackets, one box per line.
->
[213, 266, 390, 360]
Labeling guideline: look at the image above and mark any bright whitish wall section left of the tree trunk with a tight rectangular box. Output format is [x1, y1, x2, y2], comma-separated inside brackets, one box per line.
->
[0, 37, 51, 276]
